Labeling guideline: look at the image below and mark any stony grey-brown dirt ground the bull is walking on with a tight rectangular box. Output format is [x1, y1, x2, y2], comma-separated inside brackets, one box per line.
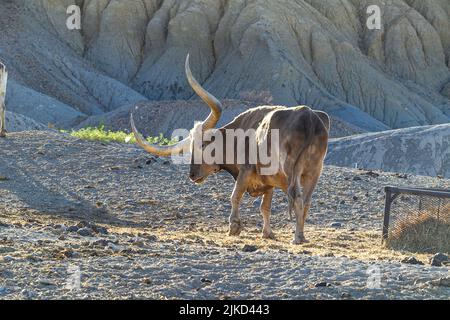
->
[0, 132, 450, 299]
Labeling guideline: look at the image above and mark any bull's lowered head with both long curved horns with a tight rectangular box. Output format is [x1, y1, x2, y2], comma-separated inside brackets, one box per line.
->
[131, 55, 222, 183]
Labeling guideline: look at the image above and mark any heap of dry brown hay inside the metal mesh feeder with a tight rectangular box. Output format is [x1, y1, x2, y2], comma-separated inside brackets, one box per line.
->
[386, 214, 450, 253]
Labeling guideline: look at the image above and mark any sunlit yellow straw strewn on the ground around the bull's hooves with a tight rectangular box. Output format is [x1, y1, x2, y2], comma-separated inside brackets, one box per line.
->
[127, 226, 429, 262]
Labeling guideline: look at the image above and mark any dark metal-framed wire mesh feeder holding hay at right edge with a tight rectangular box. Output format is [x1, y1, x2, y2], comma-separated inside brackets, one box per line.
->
[383, 187, 450, 251]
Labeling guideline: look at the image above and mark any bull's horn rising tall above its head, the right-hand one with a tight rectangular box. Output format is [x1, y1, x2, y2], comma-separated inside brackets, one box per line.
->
[185, 54, 222, 130]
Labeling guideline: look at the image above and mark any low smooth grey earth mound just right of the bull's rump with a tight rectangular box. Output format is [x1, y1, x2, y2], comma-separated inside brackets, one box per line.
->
[326, 124, 450, 178]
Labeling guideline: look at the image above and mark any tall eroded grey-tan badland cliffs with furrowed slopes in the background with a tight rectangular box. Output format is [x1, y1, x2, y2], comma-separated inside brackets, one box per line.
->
[0, 0, 450, 130]
